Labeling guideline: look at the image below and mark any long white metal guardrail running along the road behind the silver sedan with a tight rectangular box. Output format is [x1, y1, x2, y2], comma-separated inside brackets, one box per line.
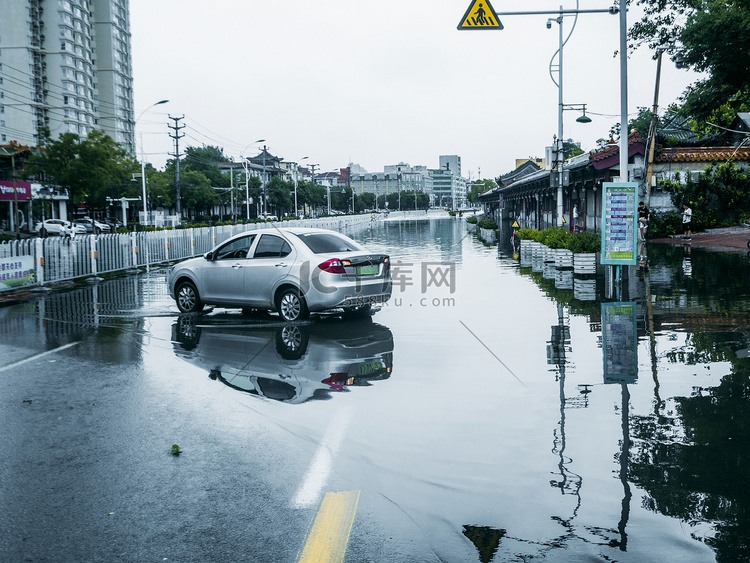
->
[0, 215, 372, 292]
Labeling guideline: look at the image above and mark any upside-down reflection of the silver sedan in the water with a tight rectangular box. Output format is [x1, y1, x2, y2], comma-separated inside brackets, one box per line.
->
[172, 315, 393, 404]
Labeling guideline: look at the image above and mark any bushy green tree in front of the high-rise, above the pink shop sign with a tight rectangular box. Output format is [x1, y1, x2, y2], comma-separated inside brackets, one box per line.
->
[25, 130, 138, 208]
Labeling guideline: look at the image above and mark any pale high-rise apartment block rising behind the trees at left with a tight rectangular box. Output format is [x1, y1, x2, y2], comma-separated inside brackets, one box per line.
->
[0, 0, 135, 152]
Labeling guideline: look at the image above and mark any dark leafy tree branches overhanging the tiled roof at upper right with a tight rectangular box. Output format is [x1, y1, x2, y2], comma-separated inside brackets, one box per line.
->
[629, 0, 750, 129]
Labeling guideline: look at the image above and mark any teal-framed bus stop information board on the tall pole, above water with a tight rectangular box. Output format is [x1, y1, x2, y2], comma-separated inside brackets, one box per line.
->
[601, 182, 638, 266]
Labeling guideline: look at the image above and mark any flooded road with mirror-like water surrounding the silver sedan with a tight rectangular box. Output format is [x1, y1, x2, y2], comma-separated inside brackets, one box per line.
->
[0, 219, 750, 562]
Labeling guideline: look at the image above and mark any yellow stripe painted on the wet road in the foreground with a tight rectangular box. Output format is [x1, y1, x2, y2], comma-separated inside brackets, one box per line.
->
[297, 491, 359, 563]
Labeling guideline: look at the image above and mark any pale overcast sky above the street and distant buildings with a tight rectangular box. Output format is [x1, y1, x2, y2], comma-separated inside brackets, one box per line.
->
[130, 0, 695, 179]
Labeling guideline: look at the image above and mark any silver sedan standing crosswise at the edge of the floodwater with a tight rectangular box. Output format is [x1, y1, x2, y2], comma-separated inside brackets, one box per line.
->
[168, 228, 392, 321]
